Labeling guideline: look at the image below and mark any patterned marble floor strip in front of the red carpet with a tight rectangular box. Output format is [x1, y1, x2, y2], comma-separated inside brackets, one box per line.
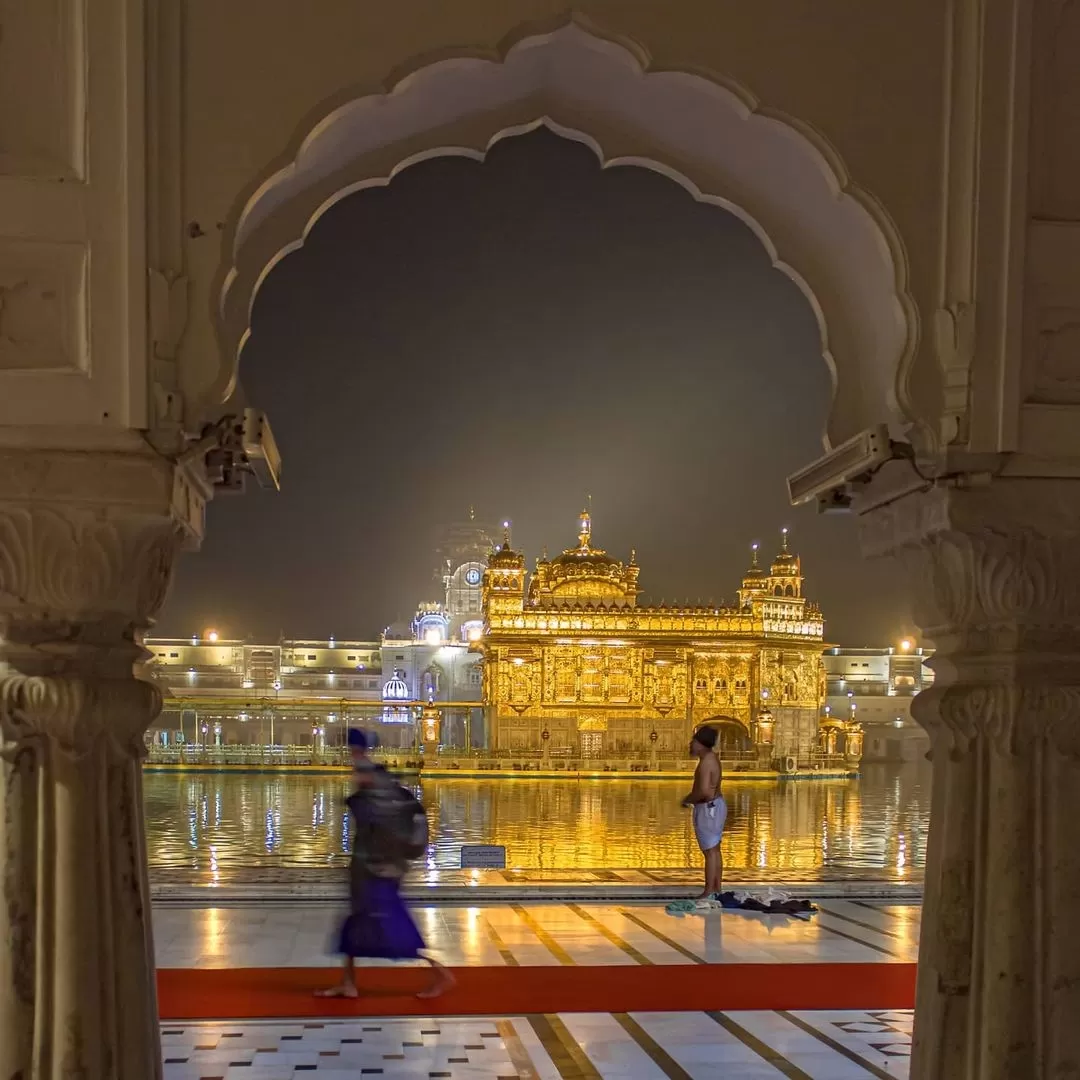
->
[162, 1010, 912, 1080]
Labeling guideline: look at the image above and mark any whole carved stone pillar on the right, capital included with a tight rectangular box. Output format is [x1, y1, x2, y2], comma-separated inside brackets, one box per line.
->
[863, 480, 1080, 1080]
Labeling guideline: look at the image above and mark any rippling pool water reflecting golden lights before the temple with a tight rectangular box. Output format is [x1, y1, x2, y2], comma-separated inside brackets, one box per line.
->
[144, 762, 930, 878]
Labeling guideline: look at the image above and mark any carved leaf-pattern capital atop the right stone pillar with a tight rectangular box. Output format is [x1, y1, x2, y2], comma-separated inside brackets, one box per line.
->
[861, 480, 1080, 755]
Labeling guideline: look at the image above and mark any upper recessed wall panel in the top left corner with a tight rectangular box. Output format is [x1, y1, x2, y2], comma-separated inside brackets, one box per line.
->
[0, 0, 86, 180]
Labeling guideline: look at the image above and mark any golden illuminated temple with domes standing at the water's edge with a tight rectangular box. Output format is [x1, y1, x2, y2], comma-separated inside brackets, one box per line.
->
[472, 512, 861, 771]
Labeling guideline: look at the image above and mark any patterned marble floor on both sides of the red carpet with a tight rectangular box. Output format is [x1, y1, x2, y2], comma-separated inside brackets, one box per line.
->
[154, 900, 920, 1080]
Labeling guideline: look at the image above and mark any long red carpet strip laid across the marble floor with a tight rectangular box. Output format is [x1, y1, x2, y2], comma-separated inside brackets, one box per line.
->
[158, 963, 916, 1021]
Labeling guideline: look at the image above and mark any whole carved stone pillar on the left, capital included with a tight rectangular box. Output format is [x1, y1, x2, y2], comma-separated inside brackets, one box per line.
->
[0, 447, 201, 1080]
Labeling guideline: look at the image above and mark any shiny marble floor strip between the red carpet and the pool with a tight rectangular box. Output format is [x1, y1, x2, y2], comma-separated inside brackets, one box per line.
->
[154, 900, 920, 972]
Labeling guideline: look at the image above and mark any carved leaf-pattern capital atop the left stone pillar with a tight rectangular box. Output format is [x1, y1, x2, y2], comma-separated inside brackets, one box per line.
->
[0, 445, 205, 630]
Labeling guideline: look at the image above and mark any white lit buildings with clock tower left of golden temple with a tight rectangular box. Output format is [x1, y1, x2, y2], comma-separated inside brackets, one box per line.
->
[146, 520, 491, 751]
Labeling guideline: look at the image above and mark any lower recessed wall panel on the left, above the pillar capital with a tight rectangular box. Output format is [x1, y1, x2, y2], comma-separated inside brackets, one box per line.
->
[0, 238, 90, 373]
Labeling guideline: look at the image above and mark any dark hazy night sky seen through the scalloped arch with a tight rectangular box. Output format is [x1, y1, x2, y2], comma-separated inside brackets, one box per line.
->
[158, 132, 910, 645]
